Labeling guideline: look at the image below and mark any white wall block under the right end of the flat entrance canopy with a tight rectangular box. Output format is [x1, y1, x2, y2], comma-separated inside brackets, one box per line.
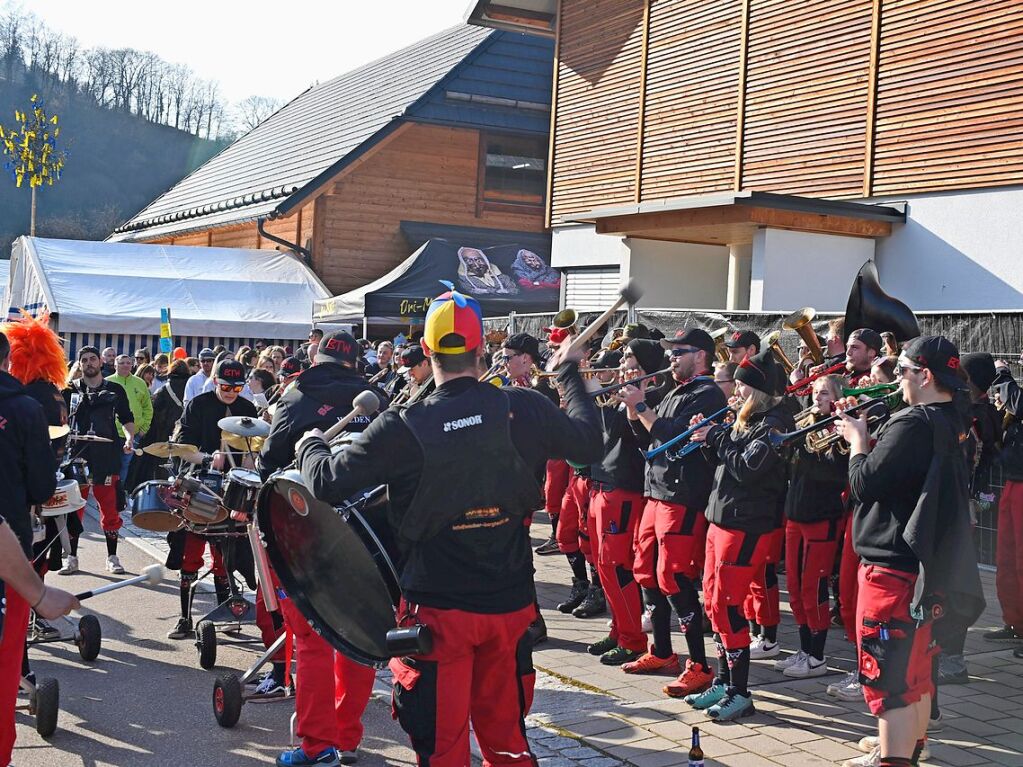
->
[750, 229, 875, 312]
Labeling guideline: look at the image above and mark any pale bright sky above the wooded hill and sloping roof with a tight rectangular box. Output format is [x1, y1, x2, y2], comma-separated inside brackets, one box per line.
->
[17, 0, 470, 102]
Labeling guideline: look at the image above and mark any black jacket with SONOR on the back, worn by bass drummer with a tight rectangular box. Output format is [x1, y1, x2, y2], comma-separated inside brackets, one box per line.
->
[298, 364, 602, 614]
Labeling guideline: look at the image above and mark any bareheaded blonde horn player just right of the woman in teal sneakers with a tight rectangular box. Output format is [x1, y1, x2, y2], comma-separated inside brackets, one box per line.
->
[774, 375, 849, 679]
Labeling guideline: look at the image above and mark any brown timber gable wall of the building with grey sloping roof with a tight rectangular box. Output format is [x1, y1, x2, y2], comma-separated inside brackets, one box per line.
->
[149, 123, 543, 295]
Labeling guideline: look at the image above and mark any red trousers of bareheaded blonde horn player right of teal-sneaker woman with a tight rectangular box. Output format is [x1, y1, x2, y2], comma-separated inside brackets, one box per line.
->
[785, 520, 842, 631]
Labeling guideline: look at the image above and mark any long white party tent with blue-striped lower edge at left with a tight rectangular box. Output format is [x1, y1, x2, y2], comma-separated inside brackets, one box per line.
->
[8, 237, 329, 356]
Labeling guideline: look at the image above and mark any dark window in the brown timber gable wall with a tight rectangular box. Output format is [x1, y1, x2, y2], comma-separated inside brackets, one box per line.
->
[480, 133, 547, 208]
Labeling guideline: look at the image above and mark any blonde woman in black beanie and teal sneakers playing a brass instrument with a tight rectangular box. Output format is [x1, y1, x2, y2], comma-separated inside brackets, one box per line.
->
[685, 350, 795, 721]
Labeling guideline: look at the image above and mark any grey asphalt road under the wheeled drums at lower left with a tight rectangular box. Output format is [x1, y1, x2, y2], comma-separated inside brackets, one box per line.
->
[13, 517, 414, 767]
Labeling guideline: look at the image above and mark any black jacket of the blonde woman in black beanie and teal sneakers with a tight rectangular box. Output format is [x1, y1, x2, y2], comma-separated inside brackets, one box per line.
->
[705, 404, 795, 534]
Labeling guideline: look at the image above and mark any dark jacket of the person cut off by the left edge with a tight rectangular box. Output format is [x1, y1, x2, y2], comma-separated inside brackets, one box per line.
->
[0, 371, 57, 556]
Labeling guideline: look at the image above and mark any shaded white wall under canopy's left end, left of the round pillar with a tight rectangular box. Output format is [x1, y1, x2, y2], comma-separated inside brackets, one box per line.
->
[622, 237, 728, 309]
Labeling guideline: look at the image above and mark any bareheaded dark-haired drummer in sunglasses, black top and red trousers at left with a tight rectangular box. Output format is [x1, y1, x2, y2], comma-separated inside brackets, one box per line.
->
[61, 347, 135, 575]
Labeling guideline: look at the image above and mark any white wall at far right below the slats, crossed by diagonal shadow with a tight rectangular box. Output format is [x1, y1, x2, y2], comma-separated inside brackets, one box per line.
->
[871, 187, 1023, 311]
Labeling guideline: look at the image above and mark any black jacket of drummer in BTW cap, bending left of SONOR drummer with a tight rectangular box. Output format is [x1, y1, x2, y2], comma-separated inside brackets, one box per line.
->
[259, 363, 371, 480]
